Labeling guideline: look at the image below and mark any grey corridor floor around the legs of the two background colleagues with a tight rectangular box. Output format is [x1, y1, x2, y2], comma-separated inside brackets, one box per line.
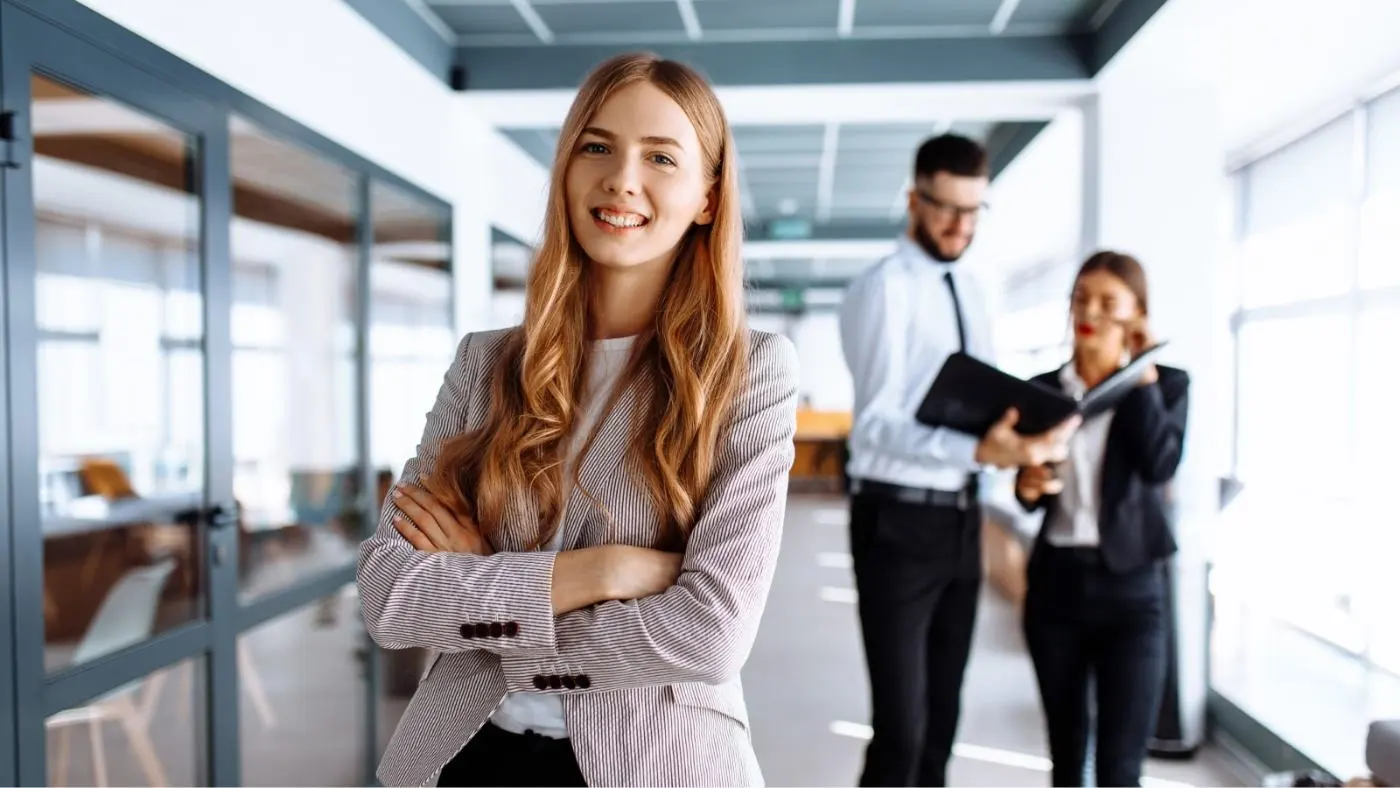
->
[743, 497, 1242, 788]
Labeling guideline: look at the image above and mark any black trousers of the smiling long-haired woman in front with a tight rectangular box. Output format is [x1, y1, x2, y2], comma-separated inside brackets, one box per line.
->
[438, 722, 588, 787]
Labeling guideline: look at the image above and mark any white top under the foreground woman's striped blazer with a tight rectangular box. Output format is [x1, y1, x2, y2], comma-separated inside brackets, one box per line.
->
[491, 336, 634, 739]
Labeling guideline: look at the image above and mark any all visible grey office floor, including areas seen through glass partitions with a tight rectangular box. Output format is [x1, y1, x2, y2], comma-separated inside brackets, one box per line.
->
[49, 497, 1240, 788]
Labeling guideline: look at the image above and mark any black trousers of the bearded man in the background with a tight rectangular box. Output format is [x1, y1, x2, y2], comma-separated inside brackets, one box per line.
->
[851, 495, 981, 785]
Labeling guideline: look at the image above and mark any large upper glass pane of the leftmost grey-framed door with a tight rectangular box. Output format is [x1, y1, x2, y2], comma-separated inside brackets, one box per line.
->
[31, 76, 204, 672]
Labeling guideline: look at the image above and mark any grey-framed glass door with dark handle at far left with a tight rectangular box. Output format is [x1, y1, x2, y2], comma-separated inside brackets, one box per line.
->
[0, 3, 238, 785]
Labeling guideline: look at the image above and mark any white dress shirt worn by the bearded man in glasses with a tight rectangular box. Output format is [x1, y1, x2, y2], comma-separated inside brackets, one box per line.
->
[841, 237, 993, 490]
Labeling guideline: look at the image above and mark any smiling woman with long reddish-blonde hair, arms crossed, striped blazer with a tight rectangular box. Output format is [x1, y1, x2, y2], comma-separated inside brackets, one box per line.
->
[360, 56, 798, 785]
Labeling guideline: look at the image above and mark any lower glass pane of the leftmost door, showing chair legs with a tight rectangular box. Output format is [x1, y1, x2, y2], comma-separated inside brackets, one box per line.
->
[45, 659, 206, 785]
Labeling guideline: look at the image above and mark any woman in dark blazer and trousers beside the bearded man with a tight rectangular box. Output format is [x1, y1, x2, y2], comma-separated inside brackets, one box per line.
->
[1016, 252, 1189, 785]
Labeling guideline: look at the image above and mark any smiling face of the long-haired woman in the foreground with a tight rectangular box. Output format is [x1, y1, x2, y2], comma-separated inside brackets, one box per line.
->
[564, 83, 713, 277]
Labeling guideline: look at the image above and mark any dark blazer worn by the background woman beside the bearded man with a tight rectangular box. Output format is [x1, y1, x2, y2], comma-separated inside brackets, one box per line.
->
[1018, 365, 1191, 572]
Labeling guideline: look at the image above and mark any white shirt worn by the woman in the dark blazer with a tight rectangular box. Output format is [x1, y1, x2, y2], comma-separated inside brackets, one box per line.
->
[1046, 361, 1113, 547]
